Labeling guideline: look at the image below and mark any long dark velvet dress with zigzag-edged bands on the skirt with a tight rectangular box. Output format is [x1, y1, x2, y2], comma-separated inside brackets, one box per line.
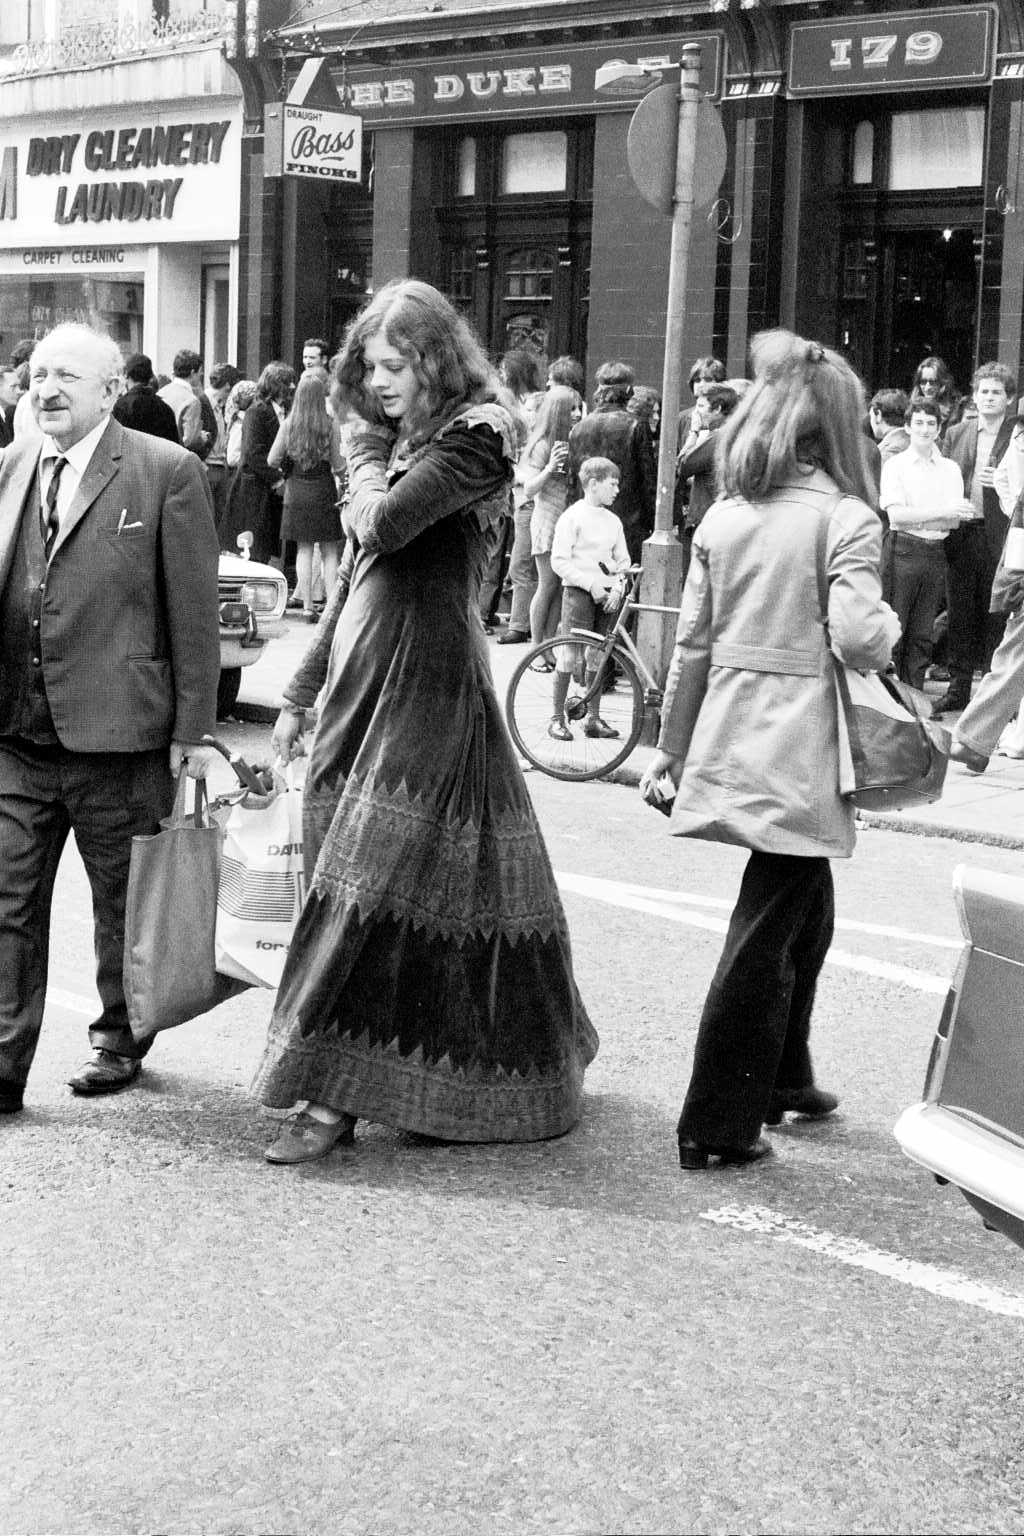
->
[253, 404, 597, 1141]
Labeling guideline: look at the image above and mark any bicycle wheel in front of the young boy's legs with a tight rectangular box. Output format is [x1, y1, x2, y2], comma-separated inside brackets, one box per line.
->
[505, 636, 643, 780]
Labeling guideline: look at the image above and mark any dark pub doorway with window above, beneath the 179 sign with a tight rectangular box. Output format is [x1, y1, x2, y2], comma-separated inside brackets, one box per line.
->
[795, 92, 987, 392]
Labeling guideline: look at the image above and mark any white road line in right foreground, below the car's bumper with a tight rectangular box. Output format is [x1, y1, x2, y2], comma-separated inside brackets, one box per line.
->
[700, 1206, 1024, 1318]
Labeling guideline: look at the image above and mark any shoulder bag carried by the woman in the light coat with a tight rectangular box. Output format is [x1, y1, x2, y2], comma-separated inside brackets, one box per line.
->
[834, 669, 950, 811]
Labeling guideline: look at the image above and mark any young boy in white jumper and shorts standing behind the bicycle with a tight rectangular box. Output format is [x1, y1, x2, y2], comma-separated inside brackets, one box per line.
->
[548, 458, 629, 742]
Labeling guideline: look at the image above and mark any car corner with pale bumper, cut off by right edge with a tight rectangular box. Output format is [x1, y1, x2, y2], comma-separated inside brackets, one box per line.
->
[895, 865, 1024, 1247]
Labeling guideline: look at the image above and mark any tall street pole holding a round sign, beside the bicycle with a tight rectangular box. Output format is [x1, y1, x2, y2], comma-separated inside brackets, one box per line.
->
[637, 43, 700, 715]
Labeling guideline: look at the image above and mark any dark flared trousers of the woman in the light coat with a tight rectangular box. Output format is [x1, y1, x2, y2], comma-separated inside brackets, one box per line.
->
[679, 851, 835, 1147]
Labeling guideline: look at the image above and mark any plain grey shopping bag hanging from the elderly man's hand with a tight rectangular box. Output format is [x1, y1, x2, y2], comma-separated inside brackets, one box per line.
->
[124, 768, 250, 1040]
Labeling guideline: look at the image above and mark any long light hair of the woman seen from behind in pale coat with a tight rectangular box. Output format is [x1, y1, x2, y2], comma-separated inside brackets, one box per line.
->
[715, 330, 875, 505]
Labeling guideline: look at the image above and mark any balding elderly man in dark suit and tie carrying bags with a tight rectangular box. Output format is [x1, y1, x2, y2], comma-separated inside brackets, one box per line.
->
[0, 326, 220, 1114]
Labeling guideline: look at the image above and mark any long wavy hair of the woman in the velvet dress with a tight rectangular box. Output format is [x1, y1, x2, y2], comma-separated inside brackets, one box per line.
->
[333, 278, 511, 445]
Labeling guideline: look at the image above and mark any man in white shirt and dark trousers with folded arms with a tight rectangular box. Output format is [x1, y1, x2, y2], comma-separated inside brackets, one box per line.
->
[878, 399, 972, 688]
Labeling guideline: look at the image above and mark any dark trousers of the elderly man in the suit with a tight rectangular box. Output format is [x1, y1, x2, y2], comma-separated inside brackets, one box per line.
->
[0, 737, 173, 1083]
